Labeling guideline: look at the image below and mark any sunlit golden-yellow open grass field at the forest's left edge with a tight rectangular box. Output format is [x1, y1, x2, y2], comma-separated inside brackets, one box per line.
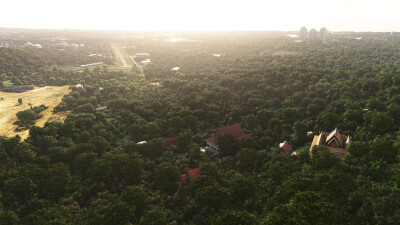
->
[0, 85, 70, 140]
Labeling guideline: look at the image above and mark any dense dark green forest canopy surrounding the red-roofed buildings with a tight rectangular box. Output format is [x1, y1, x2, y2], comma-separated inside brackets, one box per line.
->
[0, 32, 400, 225]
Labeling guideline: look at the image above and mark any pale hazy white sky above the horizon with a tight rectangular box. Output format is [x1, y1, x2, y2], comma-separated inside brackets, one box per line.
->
[0, 0, 400, 31]
